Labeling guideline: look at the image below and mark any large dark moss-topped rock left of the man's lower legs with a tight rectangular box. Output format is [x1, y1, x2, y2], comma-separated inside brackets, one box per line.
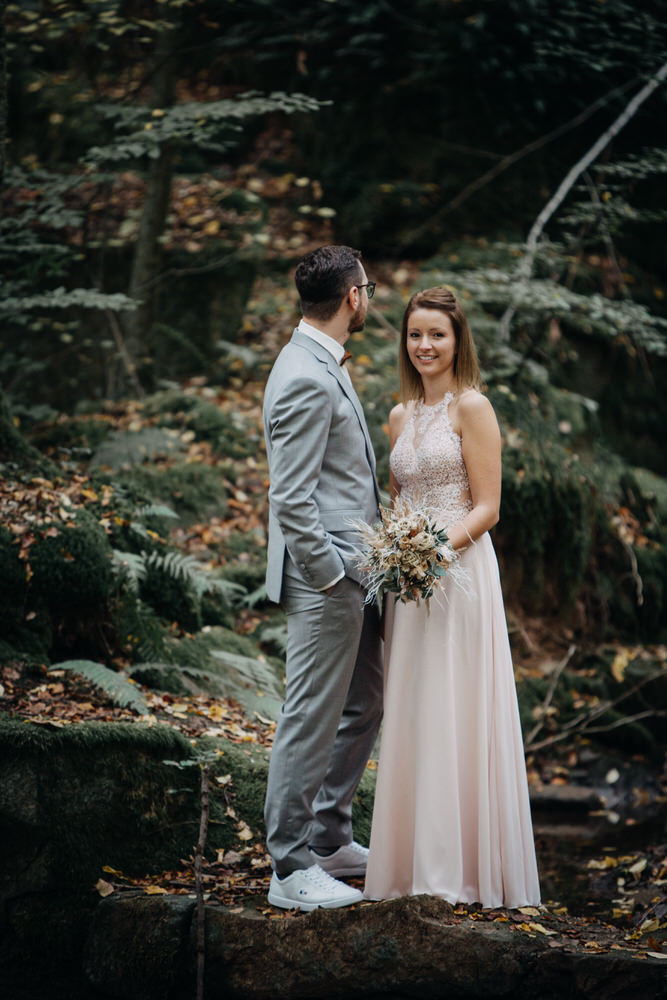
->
[0, 715, 267, 902]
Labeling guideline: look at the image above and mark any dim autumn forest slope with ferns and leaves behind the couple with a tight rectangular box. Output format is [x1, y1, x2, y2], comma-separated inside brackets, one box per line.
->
[0, 0, 667, 992]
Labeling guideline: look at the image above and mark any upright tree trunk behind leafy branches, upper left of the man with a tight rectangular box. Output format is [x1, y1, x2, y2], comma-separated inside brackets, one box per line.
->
[125, 29, 176, 382]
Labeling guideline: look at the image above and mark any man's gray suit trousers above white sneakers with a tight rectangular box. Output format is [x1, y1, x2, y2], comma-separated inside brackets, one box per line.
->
[265, 558, 383, 876]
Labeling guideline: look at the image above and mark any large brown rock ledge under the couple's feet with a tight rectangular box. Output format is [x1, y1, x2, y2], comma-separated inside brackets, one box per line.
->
[84, 894, 665, 1000]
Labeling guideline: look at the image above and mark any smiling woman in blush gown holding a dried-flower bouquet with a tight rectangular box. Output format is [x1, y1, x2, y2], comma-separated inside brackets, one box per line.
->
[365, 288, 540, 907]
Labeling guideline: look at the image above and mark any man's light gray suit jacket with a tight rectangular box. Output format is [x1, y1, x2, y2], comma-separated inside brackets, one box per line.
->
[264, 330, 379, 601]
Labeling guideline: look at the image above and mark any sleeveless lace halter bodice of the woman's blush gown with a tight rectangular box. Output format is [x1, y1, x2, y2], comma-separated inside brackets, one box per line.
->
[390, 392, 472, 528]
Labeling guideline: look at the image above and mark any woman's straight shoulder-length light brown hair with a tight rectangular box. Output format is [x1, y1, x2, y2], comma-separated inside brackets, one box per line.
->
[398, 287, 482, 405]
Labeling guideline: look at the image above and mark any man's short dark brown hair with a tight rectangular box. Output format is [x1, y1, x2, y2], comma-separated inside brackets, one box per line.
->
[294, 246, 362, 321]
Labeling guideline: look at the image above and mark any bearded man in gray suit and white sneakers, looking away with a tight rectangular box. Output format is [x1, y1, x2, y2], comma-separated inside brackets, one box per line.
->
[264, 246, 382, 910]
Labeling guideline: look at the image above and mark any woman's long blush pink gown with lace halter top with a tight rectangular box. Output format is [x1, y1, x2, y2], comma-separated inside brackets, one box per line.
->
[365, 393, 540, 907]
